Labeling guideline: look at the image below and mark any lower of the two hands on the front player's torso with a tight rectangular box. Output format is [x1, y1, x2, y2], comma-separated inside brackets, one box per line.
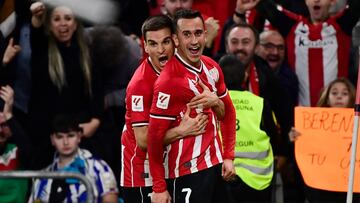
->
[178, 105, 209, 138]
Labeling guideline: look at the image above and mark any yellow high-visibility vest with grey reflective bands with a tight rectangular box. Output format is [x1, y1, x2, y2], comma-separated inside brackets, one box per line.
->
[229, 90, 274, 190]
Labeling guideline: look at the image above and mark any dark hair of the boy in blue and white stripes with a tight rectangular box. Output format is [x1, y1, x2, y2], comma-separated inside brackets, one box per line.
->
[51, 114, 82, 134]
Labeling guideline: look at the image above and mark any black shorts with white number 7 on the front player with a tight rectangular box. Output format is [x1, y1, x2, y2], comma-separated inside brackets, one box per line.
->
[167, 164, 224, 203]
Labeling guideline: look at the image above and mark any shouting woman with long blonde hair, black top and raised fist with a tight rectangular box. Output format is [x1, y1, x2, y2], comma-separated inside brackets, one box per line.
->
[29, 2, 104, 169]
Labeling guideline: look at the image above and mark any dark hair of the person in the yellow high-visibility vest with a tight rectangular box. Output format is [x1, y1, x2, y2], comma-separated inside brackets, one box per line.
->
[219, 54, 245, 90]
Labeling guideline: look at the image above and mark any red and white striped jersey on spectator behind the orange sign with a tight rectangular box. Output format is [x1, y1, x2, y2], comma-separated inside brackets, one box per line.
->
[285, 12, 351, 106]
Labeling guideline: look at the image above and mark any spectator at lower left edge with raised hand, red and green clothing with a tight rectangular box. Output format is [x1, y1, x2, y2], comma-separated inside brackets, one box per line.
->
[0, 85, 31, 203]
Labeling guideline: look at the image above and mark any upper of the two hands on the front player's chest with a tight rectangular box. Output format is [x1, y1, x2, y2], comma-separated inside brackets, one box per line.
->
[189, 80, 220, 109]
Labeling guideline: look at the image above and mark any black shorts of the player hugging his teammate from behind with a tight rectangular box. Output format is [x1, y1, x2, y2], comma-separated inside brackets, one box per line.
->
[122, 186, 152, 203]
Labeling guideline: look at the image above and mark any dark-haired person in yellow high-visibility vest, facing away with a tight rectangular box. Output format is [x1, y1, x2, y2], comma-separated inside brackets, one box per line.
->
[219, 55, 278, 202]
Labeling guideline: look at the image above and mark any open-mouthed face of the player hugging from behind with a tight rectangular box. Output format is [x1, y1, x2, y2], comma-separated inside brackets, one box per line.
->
[145, 28, 175, 71]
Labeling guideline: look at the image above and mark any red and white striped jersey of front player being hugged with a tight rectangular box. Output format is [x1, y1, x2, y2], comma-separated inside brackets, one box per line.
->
[148, 53, 227, 192]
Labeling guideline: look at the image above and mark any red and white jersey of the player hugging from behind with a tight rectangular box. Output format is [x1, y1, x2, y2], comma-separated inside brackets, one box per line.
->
[120, 58, 160, 187]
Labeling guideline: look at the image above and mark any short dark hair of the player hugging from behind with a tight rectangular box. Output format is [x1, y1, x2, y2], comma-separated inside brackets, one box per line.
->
[141, 15, 175, 41]
